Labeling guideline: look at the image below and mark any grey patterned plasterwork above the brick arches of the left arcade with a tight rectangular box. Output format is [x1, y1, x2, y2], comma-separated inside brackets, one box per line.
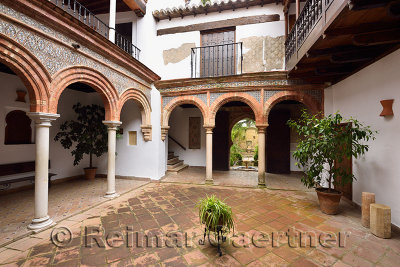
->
[0, 3, 150, 101]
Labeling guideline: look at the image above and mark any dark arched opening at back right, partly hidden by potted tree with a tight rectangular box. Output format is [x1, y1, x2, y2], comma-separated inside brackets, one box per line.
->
[266, 100, 307, 174]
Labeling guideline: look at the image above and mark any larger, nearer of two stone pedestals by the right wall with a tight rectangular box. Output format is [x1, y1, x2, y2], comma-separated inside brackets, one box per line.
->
[370, 204, 392, 238]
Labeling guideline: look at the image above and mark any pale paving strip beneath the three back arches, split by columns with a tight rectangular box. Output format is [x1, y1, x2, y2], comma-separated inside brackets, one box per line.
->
[163, 167, 309, 191]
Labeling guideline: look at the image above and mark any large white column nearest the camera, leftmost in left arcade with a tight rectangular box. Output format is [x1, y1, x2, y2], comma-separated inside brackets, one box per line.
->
[27, 112, 60, 230]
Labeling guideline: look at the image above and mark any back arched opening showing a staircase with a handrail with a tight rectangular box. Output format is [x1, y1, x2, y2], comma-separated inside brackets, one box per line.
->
[166, 102, 206, 174]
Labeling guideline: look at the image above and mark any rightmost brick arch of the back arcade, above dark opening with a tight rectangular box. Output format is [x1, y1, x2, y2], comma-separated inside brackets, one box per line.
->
[264, 91, 321, 121]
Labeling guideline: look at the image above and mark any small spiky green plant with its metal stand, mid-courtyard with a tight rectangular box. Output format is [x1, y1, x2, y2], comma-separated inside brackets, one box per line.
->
[196, 195, 234, 256]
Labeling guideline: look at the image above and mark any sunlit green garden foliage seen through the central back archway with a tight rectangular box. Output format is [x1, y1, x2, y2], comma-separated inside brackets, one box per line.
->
[230, 119, 255, 166]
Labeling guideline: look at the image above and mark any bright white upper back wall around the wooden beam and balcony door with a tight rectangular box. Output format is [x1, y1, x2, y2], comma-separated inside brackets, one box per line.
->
[137, 0, 285, 80]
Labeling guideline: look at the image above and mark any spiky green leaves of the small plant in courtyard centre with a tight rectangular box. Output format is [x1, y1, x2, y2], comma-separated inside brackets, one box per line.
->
[196, 195, 234, 232]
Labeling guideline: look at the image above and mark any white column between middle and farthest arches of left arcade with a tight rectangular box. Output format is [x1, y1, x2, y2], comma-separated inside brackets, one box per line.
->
[103, 121, 122, 198]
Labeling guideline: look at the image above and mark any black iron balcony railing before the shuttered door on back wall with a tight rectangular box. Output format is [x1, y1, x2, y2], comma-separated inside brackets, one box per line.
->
[191, 42, 243, 78]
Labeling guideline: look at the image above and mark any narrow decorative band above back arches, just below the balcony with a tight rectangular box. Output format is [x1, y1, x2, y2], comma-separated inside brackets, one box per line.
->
[159, 79, 299, 93]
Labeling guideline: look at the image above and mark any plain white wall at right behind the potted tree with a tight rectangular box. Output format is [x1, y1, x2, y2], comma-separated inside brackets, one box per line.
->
[325, 50, 400, 226]
